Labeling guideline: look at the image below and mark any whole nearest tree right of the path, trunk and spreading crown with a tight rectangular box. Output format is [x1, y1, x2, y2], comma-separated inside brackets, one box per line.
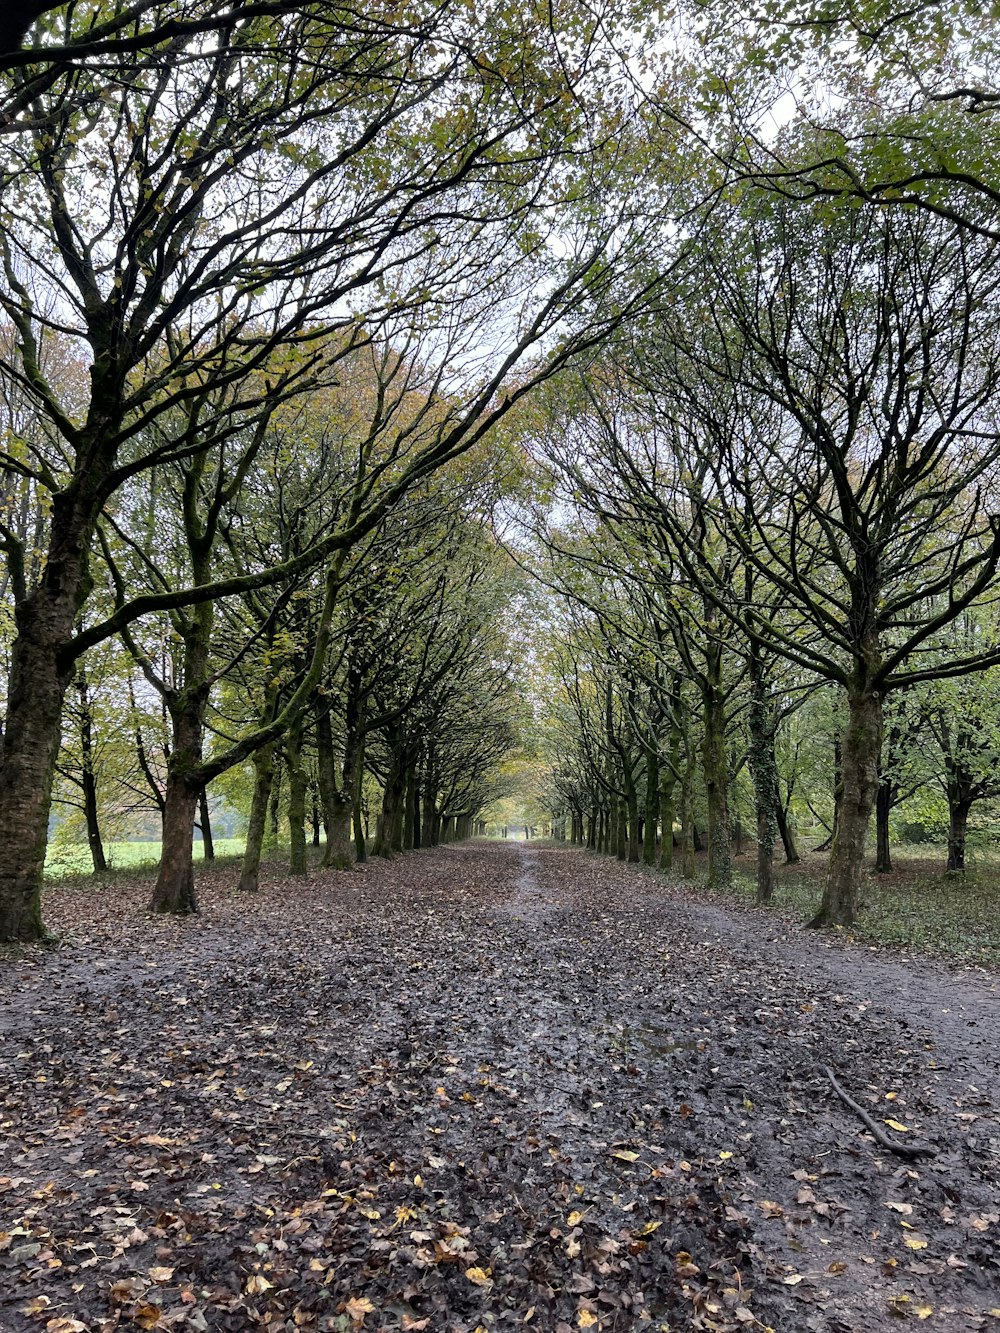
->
[695, 203, 1000, 924]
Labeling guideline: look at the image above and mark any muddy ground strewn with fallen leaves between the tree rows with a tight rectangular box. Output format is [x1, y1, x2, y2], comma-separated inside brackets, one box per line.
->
[0, 842, 1000, 1333]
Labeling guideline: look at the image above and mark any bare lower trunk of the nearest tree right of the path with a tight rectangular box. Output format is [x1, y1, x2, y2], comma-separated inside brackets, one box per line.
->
[809, 686, 883, 926]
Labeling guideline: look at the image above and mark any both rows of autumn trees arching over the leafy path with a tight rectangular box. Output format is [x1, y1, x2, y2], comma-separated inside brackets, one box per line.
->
[0, 0, 1000, 940]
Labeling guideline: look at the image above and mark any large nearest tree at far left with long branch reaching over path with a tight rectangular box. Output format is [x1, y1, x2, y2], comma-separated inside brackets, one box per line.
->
[0, 0, 674, 938]
